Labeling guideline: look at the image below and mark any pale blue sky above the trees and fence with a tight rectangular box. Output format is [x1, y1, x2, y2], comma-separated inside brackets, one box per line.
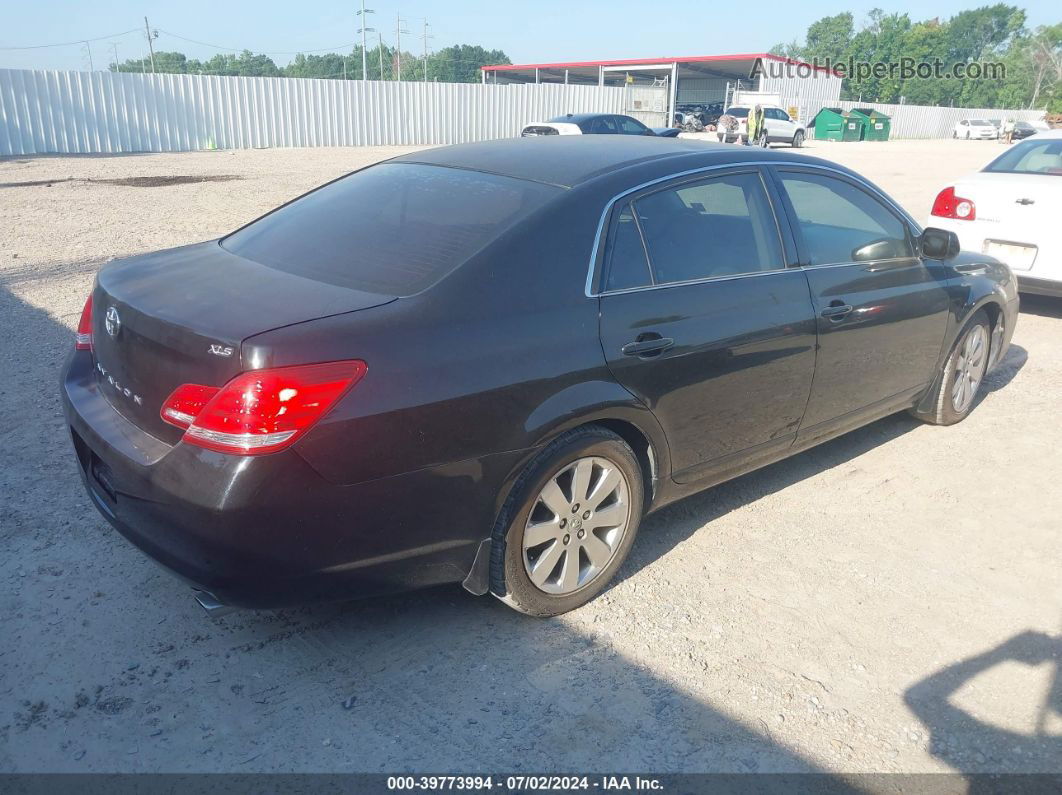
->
[0, 0, 1062, 69]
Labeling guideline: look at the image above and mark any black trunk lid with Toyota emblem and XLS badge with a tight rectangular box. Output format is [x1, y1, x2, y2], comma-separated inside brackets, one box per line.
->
[92, 241, 394, 443]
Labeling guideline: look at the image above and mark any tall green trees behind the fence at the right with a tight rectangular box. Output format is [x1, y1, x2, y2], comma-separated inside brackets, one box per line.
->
[771, 3, 1062, 113]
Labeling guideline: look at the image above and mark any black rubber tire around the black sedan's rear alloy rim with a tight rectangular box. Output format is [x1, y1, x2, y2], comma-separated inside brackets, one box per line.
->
[491, 426, 645, 617]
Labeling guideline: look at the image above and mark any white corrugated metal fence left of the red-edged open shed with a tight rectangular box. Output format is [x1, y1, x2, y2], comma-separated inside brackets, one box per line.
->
[0, 69, 624, 155]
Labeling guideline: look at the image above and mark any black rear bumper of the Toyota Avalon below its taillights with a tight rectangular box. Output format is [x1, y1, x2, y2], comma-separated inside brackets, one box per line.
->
[62, 351, 520, 607]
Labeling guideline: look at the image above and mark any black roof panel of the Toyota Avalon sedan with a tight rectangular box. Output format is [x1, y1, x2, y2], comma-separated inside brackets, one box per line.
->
[389, 135, 847, 188]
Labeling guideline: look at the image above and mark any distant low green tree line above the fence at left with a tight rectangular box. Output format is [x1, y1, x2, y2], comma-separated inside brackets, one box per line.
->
[110, 45, 512, 83]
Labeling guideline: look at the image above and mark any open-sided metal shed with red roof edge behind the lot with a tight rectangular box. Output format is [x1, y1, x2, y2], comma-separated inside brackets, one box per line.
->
[481, 52, 841, 128]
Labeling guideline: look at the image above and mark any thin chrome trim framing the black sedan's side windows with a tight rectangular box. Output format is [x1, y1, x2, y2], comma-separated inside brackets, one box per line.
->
[583, 160, 922, 298]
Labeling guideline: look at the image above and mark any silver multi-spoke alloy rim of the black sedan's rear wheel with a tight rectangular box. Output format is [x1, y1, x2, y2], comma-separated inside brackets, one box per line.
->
[524, 456, 631, 595]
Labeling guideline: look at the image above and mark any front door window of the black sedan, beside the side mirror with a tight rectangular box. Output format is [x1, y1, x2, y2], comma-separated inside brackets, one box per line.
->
[778, 171, 914, 265]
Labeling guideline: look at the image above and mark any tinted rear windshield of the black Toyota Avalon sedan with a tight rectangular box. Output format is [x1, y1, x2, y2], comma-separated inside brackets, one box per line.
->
[221, 163, 561, 296]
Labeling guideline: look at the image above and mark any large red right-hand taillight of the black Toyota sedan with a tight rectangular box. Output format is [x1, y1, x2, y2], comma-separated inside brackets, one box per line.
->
[160, 360, 366, 455]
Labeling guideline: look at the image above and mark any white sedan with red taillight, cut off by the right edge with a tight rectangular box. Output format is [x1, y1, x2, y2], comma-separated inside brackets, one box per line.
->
[927, 129, 1062, 297]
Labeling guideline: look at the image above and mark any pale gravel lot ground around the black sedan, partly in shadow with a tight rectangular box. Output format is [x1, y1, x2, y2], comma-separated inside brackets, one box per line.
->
[0, 141, 1062, 773]
